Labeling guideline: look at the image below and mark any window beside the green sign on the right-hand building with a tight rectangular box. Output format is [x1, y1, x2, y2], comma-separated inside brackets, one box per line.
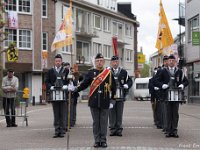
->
[188, 15, 199, 42]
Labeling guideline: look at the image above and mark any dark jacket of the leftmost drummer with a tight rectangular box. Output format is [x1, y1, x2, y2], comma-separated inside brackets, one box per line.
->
[45, 67, 69, 92]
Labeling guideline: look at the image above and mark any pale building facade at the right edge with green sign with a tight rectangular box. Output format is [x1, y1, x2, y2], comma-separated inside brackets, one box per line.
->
[185, 0, 200, 103]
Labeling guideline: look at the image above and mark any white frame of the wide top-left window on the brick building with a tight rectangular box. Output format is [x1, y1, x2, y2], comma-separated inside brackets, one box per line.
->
[6, 0, 32, 14]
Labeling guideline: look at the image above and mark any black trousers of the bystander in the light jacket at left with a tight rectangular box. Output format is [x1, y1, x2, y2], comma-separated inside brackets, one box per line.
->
[3, 97, 15, 125]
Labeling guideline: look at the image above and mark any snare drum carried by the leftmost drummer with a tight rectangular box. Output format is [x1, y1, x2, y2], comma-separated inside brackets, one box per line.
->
[49, 89, 67, 102]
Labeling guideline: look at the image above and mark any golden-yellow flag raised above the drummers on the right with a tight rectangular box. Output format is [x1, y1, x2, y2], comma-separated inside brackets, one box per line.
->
[156, 0, 174, 54]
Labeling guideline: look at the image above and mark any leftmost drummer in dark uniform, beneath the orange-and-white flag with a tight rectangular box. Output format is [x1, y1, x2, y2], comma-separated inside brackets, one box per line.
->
[45, 54, 69, 138]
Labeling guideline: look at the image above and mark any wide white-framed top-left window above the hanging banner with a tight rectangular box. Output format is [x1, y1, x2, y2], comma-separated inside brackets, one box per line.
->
[5, 0, 31, 14]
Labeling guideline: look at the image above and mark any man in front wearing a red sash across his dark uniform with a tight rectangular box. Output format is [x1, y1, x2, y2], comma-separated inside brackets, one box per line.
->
[75, 53, 115, 148]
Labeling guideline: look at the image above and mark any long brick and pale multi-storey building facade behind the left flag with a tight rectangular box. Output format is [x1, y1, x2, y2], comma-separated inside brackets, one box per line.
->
[1, 0, 139, 102]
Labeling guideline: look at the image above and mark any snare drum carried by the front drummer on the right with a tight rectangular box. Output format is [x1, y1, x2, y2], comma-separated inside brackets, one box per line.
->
[168, 88, 185, 102]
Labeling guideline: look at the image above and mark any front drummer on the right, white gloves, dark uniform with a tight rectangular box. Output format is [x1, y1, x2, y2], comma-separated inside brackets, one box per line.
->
[155, 55, 189, 138]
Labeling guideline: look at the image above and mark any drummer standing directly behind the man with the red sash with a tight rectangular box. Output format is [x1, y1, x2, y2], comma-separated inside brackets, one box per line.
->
[109, 56, 133, 136]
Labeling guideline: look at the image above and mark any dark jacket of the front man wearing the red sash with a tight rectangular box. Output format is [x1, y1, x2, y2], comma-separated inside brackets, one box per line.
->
[77, 69, 116, 109]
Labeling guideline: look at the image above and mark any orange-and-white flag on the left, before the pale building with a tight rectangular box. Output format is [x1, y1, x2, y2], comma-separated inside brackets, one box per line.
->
[51, 0, 73, 51]
